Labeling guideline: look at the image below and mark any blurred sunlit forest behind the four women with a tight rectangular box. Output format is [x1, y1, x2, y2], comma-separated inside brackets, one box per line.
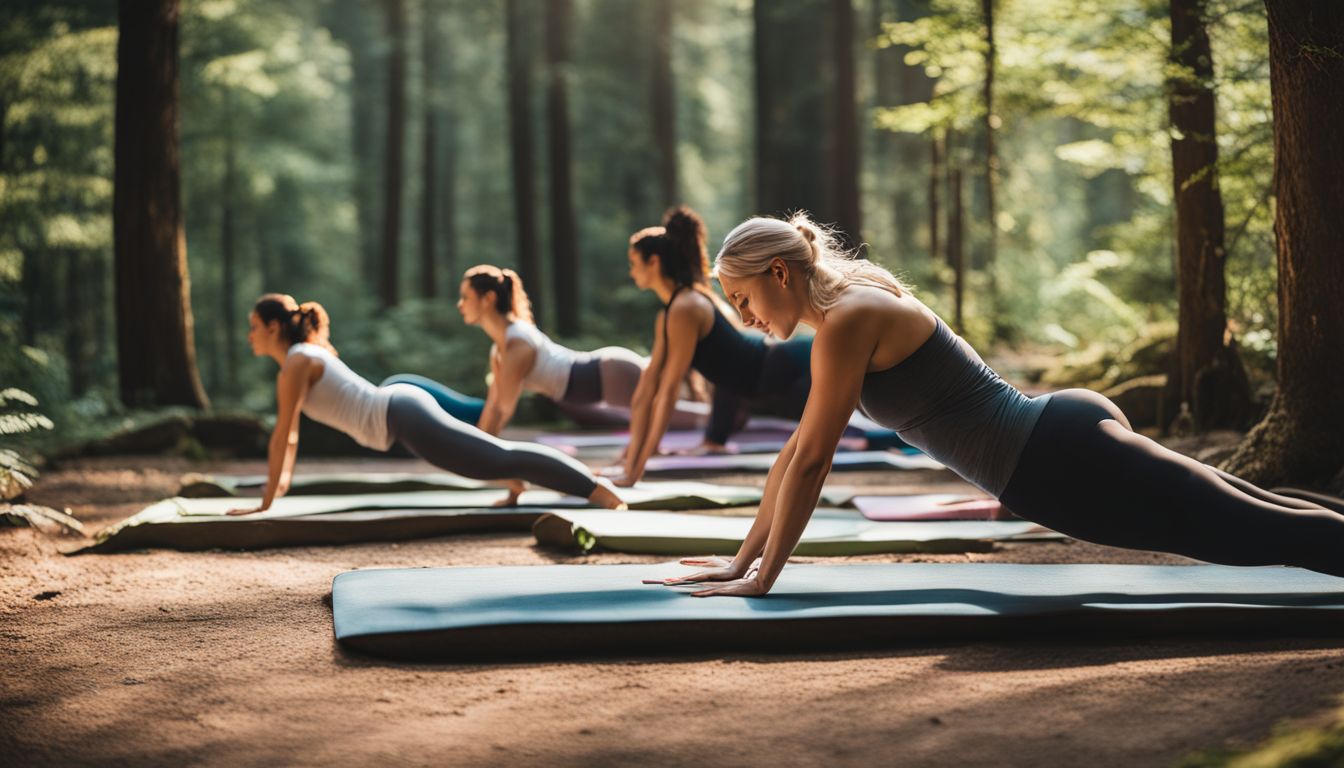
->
[0, 0, 1333, 486]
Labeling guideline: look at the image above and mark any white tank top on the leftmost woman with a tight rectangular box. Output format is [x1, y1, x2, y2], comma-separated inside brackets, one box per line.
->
[286, 344, 394, 451]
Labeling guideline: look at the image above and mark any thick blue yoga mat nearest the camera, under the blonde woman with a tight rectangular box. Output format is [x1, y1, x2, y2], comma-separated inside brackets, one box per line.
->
[332, 564, 1344, 662]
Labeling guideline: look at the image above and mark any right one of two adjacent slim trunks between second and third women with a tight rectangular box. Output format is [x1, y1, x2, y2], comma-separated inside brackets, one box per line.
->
[546, 0, 579, 336]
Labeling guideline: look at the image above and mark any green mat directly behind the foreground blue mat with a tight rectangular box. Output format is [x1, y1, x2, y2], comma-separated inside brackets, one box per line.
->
[532, 510, 1064, 557]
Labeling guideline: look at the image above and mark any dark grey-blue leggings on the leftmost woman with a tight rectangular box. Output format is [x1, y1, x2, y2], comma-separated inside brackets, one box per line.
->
[387, 385, 597, 499]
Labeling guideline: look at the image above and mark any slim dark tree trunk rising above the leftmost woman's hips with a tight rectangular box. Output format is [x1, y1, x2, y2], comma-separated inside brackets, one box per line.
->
[378, 0, 406, 308]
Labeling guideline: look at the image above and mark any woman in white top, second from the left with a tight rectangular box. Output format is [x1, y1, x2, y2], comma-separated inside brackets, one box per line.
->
[383, 264, 704, 434]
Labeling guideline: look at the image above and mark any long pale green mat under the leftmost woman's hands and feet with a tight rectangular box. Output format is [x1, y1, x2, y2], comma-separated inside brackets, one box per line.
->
[71, 482, 817, 554]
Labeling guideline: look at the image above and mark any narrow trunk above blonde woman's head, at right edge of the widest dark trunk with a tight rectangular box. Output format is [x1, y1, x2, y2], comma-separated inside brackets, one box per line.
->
[828, 0, 863, 247]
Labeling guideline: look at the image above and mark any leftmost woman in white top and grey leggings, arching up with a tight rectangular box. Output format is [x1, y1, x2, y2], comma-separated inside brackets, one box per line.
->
[233, 293, 625, 514]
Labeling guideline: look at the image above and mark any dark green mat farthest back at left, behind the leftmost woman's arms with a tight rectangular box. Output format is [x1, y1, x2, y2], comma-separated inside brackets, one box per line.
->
[175, 472, 487, 499]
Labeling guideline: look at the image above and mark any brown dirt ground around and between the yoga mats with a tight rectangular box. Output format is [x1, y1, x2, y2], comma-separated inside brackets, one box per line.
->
[0, 457, 1344, 768]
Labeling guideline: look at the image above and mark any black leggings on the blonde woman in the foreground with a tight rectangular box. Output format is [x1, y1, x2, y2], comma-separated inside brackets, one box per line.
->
[1000, 390, 1344, 576]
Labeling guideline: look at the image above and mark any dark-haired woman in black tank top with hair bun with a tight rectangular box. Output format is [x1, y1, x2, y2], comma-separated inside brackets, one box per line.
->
[616, 207, 812, 486]
